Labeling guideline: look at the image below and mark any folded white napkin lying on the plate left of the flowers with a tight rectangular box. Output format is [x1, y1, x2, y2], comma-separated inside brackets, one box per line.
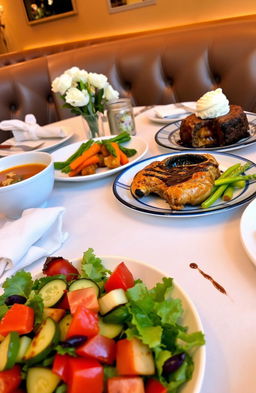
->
[0, 114, 66, 142]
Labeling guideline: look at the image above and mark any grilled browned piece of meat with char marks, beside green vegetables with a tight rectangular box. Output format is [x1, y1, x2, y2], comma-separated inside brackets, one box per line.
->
[131, 154, 220, 210]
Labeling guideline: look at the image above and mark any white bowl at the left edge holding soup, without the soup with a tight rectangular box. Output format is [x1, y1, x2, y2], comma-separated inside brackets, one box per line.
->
[0, 151, 54, 218]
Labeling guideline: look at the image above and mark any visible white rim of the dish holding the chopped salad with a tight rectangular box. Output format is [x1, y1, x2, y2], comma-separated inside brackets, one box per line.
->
[31, 256, 206, 393]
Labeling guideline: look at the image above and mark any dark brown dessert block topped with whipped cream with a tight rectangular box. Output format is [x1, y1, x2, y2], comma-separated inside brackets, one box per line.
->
[180, 89, 249, 148]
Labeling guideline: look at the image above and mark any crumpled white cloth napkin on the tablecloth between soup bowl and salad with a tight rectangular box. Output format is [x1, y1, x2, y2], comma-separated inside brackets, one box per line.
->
[0, 207, 68, 278]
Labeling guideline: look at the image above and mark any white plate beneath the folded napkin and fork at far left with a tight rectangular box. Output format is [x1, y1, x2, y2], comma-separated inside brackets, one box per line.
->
[0, 127, 74, 157]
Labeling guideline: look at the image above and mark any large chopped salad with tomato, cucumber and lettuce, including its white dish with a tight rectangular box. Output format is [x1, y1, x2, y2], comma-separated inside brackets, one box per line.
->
[0, 248, 205, 393]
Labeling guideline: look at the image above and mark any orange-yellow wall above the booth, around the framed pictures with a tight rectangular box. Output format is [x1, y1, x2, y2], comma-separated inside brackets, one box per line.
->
[0, 0, 256, 51]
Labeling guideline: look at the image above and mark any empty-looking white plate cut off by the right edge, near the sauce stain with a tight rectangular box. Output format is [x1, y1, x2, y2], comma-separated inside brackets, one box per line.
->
[240, 199, 256, 265]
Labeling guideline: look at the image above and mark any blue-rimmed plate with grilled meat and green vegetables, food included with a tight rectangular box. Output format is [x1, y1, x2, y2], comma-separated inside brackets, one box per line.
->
[113, 150, 256, 217]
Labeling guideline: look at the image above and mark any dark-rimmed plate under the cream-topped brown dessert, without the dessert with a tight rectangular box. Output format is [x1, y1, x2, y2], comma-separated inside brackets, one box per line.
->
[155, 112, 256, 152]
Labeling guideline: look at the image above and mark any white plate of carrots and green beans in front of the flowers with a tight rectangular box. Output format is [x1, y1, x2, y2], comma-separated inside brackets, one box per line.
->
[52, 132, 148, 182]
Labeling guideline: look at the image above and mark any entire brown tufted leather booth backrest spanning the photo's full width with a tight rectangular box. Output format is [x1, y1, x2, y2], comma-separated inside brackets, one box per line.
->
[0, 16, 256, 139]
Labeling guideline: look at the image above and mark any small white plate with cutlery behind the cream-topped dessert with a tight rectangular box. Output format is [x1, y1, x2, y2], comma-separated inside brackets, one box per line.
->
[155, 102, 195, 119]
